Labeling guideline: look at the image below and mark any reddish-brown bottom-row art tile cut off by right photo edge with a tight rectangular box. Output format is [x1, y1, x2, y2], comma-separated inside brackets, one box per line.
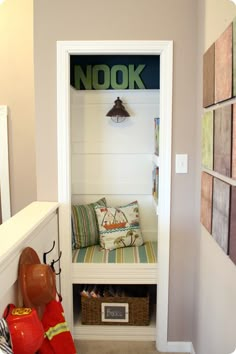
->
[229, 186, 236, 264]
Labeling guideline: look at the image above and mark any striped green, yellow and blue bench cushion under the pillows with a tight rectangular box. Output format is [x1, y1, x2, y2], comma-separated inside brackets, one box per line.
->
[72, 241, 157, 263]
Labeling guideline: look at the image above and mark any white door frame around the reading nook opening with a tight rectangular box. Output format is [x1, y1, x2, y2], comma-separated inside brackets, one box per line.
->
[57, 41, 173, 351]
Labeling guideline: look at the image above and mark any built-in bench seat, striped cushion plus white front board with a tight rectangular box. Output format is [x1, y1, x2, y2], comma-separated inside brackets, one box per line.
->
[72, 241, 158, 284]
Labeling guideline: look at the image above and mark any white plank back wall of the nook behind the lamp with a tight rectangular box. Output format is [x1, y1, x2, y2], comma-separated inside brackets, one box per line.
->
[70, 88, 159, 239]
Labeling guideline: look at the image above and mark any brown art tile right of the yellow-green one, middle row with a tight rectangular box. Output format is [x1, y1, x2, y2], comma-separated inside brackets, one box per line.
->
[213, 105, 232, 177]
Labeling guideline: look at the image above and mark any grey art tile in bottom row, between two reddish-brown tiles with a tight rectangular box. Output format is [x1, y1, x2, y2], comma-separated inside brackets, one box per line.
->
[212, 177, 230, 254]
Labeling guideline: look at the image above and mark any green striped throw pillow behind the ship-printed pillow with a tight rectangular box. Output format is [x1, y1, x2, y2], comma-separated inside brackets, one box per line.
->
[71, 198, 106, 249]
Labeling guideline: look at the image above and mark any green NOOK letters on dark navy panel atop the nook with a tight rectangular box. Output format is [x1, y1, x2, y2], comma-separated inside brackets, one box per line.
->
[70, 55, 160, 90]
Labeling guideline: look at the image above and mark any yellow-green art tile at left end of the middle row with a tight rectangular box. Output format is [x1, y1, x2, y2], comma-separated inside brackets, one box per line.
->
[202, 110, 214, 170]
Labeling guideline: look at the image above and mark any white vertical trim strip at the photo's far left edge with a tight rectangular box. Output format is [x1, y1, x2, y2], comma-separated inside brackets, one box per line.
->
[0, 106, 11, 222]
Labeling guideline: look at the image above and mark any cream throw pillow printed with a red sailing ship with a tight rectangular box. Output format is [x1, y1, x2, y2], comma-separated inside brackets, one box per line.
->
[95, 201, 143, 250]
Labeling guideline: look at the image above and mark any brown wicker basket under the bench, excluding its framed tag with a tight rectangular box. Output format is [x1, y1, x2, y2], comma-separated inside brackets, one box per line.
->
[81, 295, 149, 326]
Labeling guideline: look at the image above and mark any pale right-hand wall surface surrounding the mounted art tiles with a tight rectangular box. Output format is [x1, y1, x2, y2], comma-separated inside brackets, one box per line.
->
[193, 0, 236, 354]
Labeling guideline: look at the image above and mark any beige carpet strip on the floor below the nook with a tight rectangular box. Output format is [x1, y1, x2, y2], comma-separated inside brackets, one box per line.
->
[75, 341, 186, 354]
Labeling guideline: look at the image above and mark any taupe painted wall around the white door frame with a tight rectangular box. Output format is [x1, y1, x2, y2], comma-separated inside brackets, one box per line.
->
[34, 0, 200, 341]
